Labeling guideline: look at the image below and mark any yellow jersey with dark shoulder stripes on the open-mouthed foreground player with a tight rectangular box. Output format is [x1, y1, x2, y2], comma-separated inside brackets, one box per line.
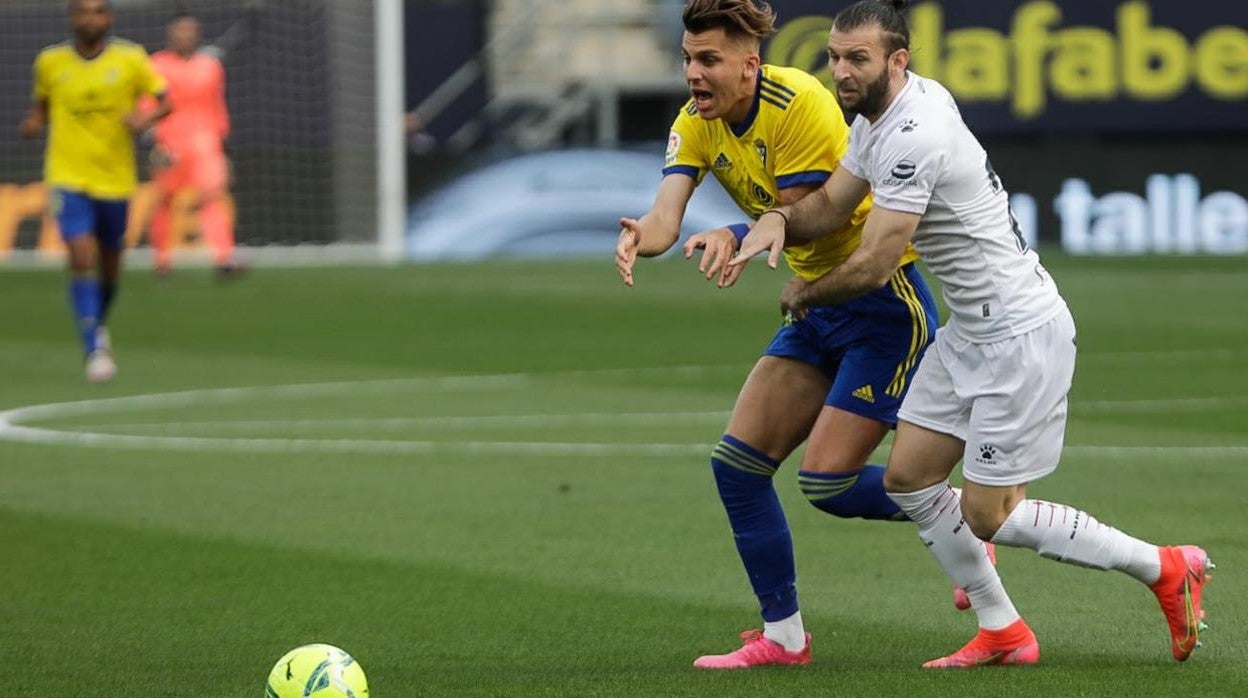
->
[663, 65, 919, 280]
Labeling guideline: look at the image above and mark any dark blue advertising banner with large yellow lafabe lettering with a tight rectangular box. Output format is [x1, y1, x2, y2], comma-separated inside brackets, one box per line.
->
[763, 0, 1248, 135]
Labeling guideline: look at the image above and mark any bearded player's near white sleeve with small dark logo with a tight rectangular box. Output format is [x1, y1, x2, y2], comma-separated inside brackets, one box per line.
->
[870, 129, 950, 215]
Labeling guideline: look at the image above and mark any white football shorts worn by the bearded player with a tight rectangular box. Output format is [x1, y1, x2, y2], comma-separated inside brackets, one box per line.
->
[897, 307, 1076, 487]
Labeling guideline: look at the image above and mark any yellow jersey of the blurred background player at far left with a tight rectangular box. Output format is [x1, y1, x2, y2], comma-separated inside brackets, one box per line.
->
[35, 39, 165, 199]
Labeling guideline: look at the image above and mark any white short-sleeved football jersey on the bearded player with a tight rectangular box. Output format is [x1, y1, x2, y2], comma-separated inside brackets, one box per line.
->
[841, 72, 1065, 343]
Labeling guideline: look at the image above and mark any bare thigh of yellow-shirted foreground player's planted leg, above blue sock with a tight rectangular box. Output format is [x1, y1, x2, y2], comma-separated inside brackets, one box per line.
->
[728, 356, 830, 461]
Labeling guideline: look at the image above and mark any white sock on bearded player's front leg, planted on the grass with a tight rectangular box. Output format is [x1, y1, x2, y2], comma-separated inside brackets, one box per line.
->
[889, 479, 1018, 631]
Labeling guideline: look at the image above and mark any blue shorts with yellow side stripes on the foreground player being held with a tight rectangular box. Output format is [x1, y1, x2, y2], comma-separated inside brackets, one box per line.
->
[763, 263, 937, 425]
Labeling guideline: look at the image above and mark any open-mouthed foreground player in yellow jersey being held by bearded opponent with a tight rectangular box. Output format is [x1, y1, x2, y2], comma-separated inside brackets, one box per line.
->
[615, 0, 936, 669]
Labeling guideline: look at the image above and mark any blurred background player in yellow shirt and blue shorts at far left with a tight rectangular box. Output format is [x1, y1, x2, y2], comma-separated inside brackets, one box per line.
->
[21, 0, 170, 381]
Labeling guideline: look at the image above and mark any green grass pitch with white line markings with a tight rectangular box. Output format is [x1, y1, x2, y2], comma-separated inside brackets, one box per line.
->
[0, 253, 1248, 698]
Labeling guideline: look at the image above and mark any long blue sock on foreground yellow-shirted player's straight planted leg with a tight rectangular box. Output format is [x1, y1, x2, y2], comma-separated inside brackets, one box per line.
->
[710, 435, 797, 623]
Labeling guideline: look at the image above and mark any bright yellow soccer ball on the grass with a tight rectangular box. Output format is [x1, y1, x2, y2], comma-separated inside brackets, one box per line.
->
[265, 644, 368, 698]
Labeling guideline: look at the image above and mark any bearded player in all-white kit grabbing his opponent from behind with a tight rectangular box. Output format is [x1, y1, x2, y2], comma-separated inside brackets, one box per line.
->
[731, 0, 1213, 667]
